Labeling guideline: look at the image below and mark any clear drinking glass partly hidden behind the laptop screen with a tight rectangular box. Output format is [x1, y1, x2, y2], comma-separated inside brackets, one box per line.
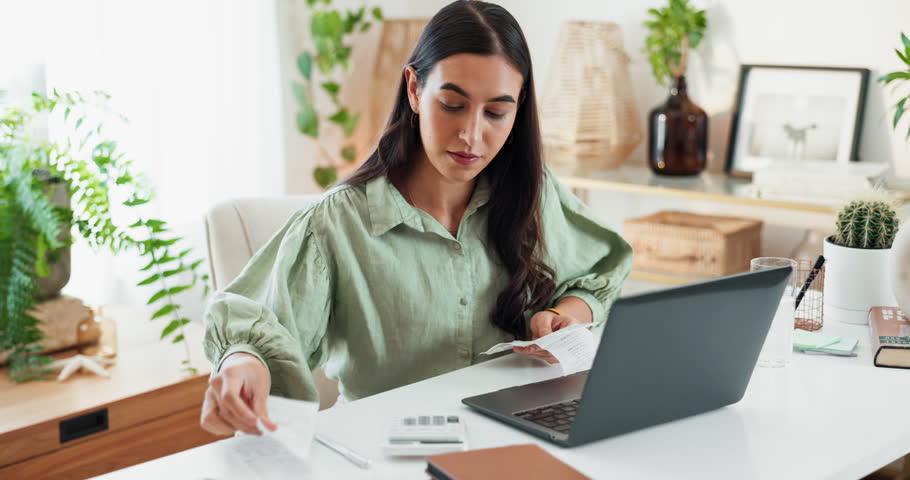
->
[750, 257, 797, 367]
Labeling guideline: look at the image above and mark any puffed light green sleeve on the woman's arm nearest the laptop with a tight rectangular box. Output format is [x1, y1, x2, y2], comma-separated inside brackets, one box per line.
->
[542, 169, 632, 324]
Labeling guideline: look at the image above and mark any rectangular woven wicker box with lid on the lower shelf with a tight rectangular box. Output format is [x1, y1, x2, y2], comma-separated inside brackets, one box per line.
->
[624, 211, 762, 276]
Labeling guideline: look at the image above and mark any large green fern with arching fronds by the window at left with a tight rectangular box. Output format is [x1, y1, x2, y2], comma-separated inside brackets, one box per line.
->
[0, 90, 208, 381]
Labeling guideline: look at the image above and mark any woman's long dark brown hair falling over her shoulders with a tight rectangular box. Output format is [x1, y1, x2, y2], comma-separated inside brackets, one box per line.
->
[345, 0, 556, 338]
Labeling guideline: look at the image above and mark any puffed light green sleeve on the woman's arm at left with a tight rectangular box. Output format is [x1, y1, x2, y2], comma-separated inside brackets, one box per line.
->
[204, 207, 333, 401]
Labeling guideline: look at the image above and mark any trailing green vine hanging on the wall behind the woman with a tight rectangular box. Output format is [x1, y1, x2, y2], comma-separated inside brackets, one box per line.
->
[292, 0, 383, 188]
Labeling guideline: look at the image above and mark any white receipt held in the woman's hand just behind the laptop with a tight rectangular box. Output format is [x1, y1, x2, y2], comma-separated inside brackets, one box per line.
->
[481, 323, 597, 375]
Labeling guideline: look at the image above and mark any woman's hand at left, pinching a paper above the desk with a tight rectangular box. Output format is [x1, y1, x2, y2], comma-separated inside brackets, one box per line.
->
[199, 352, 278, 435]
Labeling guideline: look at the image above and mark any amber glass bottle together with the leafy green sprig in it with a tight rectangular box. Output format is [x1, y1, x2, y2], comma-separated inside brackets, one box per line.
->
[644, 0, 708, 175]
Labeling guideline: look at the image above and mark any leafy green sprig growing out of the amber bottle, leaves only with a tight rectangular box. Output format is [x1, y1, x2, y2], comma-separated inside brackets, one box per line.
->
[644, 0, 708, 86]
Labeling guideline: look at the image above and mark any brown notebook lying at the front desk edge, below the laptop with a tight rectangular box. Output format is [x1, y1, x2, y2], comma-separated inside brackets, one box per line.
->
[427, 444, 588, 480]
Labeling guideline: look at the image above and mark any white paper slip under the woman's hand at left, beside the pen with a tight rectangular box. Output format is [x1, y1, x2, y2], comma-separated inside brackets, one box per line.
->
[227, 396, 319, 479]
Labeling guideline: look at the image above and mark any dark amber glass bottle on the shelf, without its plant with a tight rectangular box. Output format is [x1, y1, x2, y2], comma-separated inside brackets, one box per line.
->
[648, 76, 708, 175]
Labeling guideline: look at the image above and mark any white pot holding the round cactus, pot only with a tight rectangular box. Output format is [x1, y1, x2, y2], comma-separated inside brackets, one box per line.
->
[825, 238, 897, 324]
